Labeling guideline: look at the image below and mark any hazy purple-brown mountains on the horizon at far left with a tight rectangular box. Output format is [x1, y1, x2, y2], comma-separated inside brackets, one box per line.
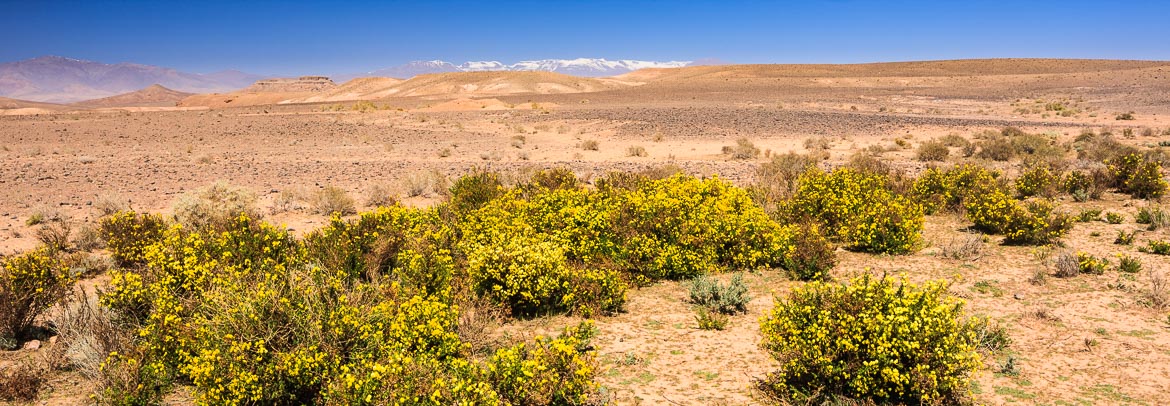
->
[0, 56, 263, 103]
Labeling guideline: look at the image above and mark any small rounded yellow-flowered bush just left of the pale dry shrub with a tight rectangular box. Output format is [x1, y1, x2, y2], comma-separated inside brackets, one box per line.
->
[99, 212, 167, 267]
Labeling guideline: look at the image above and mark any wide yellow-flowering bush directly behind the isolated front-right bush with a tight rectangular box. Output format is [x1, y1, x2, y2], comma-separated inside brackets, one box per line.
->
[789, 168, 923, 254]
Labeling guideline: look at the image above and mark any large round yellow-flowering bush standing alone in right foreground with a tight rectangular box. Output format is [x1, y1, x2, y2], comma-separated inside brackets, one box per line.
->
[761, 276, 979, 404]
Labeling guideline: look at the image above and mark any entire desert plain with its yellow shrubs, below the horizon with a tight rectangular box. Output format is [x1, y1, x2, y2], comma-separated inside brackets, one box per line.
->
[0, 60, 1170, 405]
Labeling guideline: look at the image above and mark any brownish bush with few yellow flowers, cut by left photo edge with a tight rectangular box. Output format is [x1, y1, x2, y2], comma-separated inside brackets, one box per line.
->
[0, 247, 74, 350]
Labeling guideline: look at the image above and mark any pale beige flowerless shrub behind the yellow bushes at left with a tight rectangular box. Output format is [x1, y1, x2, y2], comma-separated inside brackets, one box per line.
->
[172, 181, 261, 229]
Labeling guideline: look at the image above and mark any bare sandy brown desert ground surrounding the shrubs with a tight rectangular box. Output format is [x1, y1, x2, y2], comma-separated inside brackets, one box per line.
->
[0, 62, 1170, 405]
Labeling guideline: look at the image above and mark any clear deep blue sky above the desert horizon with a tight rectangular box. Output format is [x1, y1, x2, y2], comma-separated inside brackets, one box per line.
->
[0, 0, 1170, 74]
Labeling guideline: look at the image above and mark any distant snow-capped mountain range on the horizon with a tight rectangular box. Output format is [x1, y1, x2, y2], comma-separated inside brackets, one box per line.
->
[346, 57, 691, 81]
